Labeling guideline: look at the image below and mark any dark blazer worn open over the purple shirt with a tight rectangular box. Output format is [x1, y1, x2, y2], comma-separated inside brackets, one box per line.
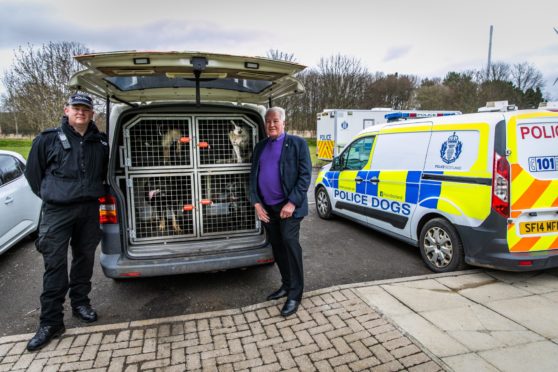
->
[250, 133, 312, 218]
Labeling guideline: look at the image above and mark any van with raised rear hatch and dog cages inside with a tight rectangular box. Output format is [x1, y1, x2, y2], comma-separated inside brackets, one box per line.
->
[70, 52, 305, 278]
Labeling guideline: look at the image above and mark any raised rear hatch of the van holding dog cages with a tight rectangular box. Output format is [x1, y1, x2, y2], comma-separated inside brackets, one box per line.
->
[70, 51, 305, 104]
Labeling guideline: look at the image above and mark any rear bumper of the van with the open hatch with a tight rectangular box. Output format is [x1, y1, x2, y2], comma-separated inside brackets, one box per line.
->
[100, 244, 274, 279]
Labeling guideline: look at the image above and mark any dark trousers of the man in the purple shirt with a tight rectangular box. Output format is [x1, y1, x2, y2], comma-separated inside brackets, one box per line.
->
[264, 204, 304, 301]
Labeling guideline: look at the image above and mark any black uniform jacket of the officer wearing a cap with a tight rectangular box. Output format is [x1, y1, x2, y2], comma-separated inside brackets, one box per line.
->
[25, 116, 109, 204]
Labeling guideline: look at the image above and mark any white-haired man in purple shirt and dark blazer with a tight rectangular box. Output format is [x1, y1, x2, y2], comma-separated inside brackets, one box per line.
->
[250, 107, 312, 317]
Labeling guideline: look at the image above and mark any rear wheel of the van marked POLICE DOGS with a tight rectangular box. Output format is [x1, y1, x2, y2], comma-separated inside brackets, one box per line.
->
[419, 218, 464, 273]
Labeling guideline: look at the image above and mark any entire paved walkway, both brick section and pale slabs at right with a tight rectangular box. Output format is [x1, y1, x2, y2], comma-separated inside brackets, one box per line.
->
[0, 270, 558, 372]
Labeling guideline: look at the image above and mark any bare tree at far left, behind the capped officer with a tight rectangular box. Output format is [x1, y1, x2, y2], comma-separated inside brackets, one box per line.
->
[2, 41, 89, 134]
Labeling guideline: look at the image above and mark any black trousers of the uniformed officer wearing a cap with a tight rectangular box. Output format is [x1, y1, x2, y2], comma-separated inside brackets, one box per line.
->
[36, 201, 101, 326]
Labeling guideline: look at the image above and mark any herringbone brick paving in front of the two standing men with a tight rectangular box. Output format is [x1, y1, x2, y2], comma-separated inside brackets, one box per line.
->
[0, 287, 444, 372]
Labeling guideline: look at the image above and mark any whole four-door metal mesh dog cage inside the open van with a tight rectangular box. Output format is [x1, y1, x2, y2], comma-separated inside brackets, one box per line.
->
[119, 114, 260, 244]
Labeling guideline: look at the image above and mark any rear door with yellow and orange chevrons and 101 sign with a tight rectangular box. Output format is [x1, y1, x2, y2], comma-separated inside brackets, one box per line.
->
[506, 112, 558, 252]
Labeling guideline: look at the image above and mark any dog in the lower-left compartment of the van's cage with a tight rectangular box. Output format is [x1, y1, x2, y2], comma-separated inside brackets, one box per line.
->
[145, 177, 182, 233]
